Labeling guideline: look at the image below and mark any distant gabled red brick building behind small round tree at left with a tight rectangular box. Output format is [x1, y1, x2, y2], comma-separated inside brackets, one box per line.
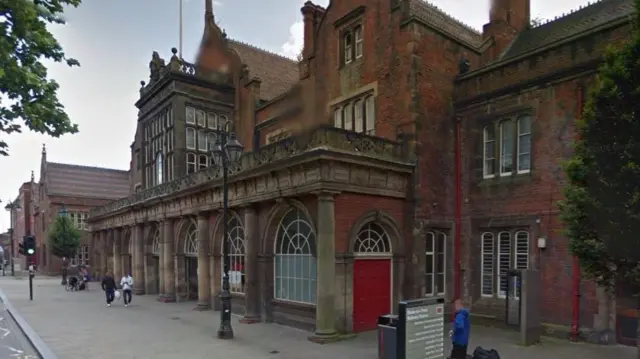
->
[32, 146, 131, 274]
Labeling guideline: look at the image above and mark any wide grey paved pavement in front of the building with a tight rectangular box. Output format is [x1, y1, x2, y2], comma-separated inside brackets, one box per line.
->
[0, 278, 635, 359]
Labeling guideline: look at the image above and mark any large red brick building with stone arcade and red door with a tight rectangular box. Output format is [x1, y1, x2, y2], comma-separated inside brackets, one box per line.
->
[89, 0, 635, 348]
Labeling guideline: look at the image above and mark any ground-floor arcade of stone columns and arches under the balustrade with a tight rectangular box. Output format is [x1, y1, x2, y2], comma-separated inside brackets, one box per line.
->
[93, 193, 405, 340]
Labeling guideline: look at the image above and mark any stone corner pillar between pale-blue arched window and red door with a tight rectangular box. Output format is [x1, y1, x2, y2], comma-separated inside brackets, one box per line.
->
[309, 192, 338, 343]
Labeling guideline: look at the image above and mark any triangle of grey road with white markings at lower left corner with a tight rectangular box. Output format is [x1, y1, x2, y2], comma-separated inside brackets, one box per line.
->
[0, 302, 38, 359]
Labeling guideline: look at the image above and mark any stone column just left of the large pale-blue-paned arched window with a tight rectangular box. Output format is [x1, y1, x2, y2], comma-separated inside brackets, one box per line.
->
[240, 207, 260, 324]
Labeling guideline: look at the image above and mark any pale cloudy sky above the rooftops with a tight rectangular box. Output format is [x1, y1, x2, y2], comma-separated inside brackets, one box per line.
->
[0, 0, 587, 233]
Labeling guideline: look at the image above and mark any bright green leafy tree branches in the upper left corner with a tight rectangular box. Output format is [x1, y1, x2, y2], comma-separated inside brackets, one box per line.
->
[0, 0, 82, 156]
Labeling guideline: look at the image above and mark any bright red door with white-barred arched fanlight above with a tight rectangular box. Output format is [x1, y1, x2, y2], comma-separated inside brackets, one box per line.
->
[353, 222, 393, 332]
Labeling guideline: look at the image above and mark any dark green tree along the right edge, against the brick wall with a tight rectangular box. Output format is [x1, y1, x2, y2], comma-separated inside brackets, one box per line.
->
[559, 0, 640, 352]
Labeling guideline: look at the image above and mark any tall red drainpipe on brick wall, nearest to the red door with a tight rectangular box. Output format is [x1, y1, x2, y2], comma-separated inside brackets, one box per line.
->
[453, 117, 462, 299]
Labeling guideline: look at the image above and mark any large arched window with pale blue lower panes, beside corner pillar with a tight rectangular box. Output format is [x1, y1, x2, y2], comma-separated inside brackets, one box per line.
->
[274, 209, 316, 304]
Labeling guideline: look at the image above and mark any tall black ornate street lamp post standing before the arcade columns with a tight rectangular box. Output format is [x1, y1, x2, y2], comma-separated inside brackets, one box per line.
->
[209, 123, 243, 339]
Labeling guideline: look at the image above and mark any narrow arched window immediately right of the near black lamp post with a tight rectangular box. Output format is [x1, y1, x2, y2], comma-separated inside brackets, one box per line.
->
[220, 216, 245, 293]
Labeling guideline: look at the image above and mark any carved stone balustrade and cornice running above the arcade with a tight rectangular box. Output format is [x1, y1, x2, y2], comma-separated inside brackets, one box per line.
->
[89, 125, 413, 229]
